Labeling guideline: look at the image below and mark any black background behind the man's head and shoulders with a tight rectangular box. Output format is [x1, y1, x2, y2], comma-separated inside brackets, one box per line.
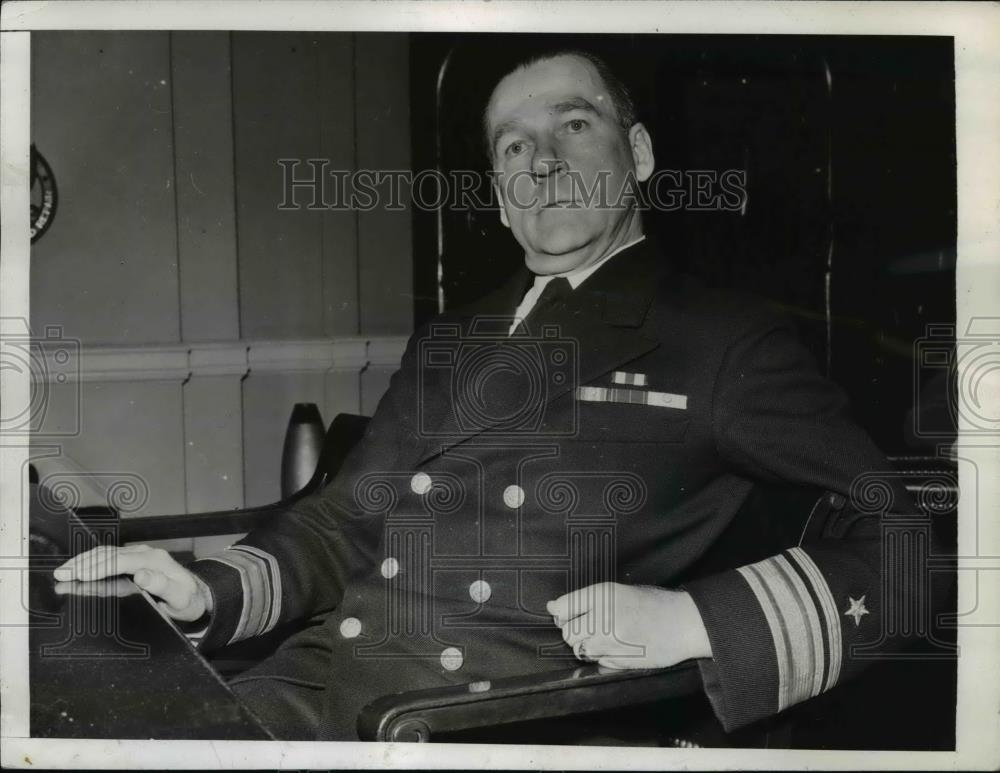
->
[410, 34, 956, 455]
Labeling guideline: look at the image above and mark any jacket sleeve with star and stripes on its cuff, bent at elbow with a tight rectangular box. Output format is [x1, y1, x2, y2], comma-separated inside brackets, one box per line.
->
[685, 314, 932, 731]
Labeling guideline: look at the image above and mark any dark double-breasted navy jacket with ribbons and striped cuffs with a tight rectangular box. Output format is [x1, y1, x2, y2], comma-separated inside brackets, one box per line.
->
[193, 241, 905, 738]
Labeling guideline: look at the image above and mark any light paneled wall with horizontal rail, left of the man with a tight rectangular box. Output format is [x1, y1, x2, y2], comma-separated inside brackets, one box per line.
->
[31, 32, 413, 552]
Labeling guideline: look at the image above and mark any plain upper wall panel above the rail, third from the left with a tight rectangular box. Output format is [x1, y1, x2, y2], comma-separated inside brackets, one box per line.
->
[233, 33, 323, 338]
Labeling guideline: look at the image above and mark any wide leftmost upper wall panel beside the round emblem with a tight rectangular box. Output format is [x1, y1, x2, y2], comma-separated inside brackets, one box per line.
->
[31, 32, 180, 344]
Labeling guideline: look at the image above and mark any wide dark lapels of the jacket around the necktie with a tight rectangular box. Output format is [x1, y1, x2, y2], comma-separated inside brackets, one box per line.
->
[418, 237, 667, 462]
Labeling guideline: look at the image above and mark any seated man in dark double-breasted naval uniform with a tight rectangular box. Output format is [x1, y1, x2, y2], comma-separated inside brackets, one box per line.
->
[56, 45, 916, 740]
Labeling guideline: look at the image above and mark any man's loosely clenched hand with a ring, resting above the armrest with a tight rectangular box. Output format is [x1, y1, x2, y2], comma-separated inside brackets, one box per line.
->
[546, 582, 712, 668]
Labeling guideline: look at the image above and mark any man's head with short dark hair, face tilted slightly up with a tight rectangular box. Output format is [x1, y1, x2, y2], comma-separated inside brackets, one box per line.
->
[486, 55, 653, 274]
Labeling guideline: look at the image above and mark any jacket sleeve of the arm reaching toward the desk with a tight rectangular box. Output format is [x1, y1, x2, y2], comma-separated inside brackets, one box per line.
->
[188, 339, 422, 650]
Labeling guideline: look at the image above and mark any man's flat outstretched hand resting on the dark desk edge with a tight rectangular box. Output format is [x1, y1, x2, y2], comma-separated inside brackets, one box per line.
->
[53, 545, 212, 622]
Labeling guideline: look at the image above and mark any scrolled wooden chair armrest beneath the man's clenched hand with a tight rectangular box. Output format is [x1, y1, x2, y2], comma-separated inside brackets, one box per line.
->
[358, 661, 702, 742]
